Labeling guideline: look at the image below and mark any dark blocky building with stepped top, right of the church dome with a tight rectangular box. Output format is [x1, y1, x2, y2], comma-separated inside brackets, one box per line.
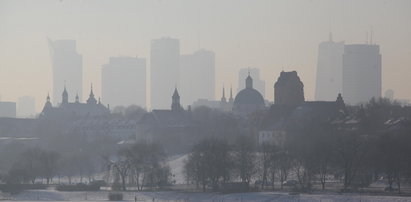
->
[274, 71, 304, 106]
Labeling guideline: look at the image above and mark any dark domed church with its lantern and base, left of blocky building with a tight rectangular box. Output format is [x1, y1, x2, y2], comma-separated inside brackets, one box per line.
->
[233, 74, 265, 117]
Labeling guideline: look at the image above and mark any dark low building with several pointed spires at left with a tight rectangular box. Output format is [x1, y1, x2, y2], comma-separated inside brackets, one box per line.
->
[40, 84, 110, 120]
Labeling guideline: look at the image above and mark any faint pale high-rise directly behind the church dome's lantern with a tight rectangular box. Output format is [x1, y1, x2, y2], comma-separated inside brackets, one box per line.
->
[237, 68, 265, 97]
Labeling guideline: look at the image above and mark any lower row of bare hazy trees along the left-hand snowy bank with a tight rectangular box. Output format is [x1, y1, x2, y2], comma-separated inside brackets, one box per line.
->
[1, 142, 171, 190]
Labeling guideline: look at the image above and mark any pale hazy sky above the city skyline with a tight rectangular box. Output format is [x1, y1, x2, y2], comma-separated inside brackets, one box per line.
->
[0, 0, 411, 110]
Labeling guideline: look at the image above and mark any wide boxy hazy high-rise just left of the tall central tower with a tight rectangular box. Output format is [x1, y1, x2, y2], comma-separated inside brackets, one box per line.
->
[101, 57, 146, 108]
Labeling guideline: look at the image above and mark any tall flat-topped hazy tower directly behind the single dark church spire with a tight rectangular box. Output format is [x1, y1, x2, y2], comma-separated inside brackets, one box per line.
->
[150, 38, 180, 109]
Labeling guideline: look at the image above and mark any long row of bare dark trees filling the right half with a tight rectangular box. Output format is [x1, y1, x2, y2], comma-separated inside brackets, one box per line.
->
[185, 119, 411, 192]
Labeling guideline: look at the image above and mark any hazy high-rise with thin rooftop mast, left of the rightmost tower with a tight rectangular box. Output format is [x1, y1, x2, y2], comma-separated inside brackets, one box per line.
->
[315, 33, 344, 101]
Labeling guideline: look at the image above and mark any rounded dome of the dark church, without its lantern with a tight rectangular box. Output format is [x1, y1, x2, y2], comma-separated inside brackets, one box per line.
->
[234, 88, 264, 106]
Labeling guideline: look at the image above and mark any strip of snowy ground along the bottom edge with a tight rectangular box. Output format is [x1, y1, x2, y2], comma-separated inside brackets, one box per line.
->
[0, 190, 411, 202]
